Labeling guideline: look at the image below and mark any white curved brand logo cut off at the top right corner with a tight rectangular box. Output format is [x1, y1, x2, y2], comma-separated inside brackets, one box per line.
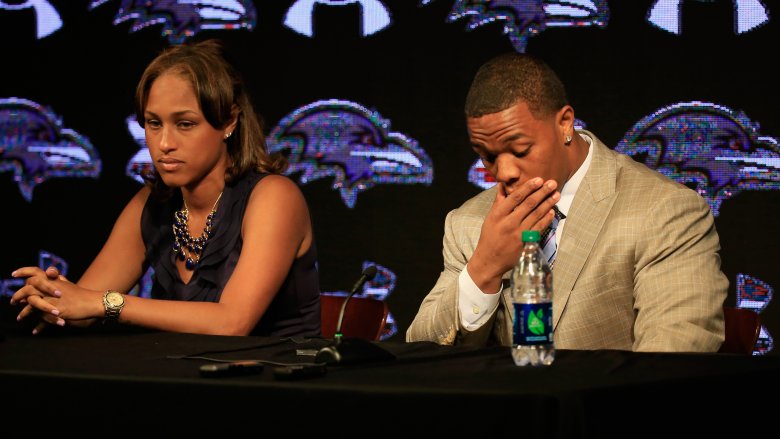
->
[647, 0, 769, 35]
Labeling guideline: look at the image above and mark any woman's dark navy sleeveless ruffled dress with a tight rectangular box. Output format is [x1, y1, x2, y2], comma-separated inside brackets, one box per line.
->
[141, 173, 320, 337]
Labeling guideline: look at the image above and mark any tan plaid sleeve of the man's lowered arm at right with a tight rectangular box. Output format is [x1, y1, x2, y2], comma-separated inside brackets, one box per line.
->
[633, 189, 729, 352]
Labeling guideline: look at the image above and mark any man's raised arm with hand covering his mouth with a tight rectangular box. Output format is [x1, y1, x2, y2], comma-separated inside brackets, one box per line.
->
[406, 178, 560, 344]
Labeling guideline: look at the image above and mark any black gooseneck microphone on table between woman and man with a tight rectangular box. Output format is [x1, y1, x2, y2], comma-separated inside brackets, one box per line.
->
[314, 265, 395, 364]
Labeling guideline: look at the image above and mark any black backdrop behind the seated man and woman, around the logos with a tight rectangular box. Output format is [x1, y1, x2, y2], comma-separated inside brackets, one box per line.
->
[0, 0, 780, 350]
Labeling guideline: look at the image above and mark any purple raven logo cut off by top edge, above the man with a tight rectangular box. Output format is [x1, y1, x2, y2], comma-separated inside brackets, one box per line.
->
[422, 0, 609, 52]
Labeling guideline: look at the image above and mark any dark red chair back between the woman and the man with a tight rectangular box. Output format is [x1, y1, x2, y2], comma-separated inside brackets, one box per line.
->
[320, 294, 388, 341]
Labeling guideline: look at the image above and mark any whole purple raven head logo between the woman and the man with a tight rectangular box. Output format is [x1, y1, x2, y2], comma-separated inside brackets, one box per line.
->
[268, 99, 433, 208]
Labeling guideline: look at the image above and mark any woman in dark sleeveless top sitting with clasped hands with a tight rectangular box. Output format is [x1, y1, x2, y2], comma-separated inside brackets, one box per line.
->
[11, 40, 320, 336]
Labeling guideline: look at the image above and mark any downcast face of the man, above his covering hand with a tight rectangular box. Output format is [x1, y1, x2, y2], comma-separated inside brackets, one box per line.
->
[466, 102, 571, 194]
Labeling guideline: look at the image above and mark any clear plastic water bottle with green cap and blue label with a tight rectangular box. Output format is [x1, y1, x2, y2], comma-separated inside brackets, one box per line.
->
[510, 230, 555, 366]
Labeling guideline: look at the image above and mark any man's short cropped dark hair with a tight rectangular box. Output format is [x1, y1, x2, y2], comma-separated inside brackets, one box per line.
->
[465, 52, 569, 118]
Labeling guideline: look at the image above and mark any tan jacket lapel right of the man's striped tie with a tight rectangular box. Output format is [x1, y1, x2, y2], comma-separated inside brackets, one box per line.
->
[553, 131, 617, 327]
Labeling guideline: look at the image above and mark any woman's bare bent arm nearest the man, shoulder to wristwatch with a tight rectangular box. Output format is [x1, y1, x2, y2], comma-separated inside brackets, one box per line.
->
[112, 175, 312, 335]
